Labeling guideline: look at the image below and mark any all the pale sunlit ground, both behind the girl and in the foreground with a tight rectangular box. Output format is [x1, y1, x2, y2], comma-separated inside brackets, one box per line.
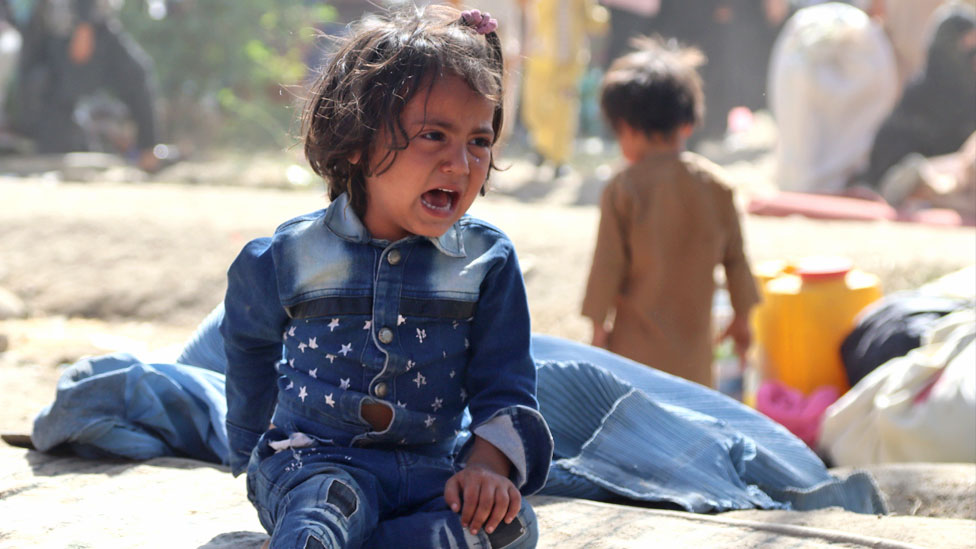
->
[0, 166, 976, 549]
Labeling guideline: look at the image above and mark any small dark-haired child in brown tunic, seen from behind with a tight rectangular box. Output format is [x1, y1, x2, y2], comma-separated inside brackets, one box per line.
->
[582, 39, 759, 386]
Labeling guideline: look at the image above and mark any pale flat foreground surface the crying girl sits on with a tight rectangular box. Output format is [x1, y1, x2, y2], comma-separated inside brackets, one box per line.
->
[0, 446, 976, 549]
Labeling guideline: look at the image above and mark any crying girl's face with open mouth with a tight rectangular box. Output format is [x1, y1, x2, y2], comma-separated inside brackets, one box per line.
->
[352, 76, 495, 241]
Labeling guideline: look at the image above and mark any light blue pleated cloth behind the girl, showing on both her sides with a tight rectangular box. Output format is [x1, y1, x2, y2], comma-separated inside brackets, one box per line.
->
[33, 309, 887, 513]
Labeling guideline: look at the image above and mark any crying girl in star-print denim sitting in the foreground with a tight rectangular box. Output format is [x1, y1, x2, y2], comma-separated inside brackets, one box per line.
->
[221, 6, 553, 548]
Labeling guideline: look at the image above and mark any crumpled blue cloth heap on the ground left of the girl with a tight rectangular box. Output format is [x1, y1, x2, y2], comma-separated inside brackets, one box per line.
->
[31, 353, 228, 463]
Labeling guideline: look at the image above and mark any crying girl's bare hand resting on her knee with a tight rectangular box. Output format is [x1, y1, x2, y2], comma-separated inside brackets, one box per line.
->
[444, 435, 522, 534]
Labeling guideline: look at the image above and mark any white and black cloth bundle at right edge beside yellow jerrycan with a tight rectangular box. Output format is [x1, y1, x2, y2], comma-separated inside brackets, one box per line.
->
[818, 267, 976, 466]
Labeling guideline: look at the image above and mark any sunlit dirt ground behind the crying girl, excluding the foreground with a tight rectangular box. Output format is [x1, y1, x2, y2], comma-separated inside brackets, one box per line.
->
[0, 149, 976, 432]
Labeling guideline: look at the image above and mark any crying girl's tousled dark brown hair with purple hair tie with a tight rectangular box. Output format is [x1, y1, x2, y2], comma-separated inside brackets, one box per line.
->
[302, 5, 504, 217]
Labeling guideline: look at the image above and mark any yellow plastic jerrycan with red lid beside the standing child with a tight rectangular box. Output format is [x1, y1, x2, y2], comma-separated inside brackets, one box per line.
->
[754, 257, 881, 394]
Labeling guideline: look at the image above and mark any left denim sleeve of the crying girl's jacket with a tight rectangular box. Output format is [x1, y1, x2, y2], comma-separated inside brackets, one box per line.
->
[220, 238, 288, 475]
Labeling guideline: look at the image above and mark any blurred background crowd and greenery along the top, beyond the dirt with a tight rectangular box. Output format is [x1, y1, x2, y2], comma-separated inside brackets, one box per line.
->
[0, 0, 976, 214]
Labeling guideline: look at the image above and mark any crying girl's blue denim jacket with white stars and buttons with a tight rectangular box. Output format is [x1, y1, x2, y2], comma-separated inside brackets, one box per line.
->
[221, 195, 552, 494]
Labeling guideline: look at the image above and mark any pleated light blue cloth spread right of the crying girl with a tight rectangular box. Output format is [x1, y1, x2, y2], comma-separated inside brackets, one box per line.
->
[533, 342, 886, 513]
